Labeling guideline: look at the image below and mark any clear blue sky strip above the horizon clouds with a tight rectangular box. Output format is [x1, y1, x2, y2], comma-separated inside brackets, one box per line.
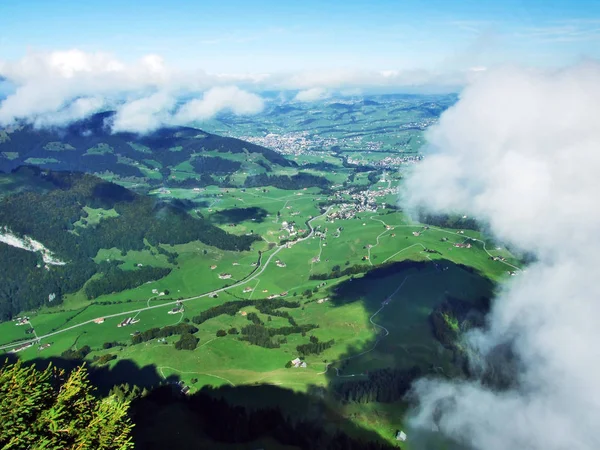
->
[0, 0, 600, 73]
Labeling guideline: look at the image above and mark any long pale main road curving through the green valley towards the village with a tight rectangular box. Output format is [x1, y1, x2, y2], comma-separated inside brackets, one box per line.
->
[0, 206, 333, 350]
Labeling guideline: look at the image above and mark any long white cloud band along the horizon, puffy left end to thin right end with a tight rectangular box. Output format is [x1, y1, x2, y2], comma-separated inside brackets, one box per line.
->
[0, 50, 475, 133]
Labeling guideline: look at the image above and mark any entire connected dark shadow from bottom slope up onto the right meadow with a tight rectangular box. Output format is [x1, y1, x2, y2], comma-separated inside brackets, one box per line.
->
[0, 260, 494, 450]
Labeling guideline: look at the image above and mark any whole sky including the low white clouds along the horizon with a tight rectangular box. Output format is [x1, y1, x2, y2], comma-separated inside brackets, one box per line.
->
[0, 0, 600, 133]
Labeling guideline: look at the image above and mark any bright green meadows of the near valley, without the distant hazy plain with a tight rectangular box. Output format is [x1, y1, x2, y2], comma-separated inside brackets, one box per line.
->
[0, 171, 517, 442]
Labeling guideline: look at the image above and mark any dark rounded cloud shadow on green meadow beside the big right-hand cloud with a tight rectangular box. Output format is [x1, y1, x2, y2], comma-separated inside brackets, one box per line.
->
[327, 260, 494, 403]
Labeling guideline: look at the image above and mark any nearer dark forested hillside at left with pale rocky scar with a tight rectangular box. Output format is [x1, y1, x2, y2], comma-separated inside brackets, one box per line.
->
[0, 168, 260, 320]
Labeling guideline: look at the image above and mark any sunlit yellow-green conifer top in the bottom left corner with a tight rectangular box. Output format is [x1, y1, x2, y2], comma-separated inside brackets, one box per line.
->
[0, 361, 133, 450]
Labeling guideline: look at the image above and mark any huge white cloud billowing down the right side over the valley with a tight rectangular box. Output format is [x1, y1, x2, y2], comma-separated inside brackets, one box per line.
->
[403, 63, 600, 450]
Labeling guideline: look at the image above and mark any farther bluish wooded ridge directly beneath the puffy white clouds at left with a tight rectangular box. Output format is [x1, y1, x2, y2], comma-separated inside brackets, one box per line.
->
[0, 112, 296, 181]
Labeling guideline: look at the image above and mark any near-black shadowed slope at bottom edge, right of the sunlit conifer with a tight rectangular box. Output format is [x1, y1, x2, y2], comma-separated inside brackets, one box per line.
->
[132, 385, 397, 450]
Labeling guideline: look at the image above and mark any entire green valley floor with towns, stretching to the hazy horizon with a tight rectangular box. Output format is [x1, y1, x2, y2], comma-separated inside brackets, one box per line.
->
[0, 96, 522, 448]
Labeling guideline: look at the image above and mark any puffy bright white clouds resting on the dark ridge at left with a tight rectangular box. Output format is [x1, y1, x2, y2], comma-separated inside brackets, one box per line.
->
[0, 50, 263, 133]
